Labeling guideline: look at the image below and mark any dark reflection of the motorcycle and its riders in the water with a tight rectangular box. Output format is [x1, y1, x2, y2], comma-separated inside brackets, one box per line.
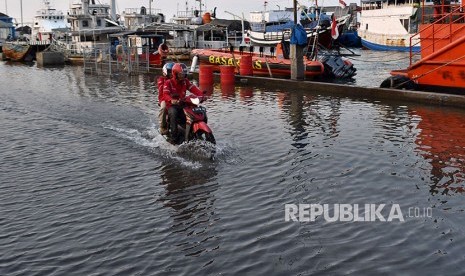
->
[159, 164, 219, 256]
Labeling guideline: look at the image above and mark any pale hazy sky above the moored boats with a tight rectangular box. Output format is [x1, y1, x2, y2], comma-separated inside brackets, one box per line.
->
[0, 0, 356, 24]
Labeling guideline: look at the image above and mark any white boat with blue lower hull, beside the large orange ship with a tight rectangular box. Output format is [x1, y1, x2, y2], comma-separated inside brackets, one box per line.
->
[358, 0, 421, 52]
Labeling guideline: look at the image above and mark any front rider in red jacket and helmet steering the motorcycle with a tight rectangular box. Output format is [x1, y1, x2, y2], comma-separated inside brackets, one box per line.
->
[163, 63, 203, 141]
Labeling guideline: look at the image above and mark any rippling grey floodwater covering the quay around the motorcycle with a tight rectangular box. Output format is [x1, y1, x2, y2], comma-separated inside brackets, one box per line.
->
[0, 50, 465, 275]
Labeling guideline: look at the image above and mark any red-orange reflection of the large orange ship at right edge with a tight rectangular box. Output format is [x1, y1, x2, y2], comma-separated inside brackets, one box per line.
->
[415, 107, 465, 195]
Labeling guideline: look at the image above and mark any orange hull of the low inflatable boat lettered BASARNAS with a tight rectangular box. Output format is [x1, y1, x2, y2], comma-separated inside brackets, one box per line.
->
[192, 49, 324, 78]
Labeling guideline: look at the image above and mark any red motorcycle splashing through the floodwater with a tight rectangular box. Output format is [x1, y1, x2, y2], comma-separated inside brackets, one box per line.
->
[166, 95, 216, 145]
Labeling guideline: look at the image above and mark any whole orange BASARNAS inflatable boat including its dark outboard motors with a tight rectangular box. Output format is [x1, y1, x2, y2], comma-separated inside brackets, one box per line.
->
[192, 42, 356, 79]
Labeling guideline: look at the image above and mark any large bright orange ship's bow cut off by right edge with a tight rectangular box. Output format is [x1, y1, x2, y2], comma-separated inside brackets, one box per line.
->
[381, 3, 465, 94]
